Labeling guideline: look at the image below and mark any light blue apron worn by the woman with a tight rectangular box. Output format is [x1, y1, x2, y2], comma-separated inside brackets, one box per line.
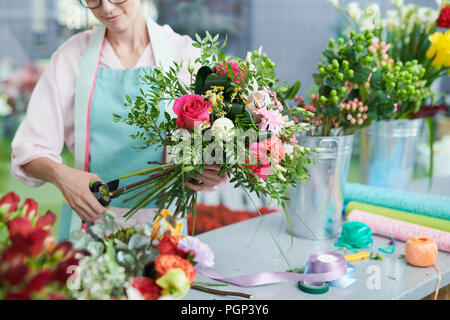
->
[57, 20, 181, 242]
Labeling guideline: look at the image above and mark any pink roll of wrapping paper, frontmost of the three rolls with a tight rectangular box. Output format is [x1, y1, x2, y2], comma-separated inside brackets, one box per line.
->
[347, 210, 450, 252]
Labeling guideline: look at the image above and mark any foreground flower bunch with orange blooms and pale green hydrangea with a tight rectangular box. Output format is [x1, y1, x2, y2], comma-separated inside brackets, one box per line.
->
[68, 210, 214, 300]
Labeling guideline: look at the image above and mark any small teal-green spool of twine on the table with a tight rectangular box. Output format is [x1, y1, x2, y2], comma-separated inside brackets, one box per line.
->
[334, 221, 373, 252]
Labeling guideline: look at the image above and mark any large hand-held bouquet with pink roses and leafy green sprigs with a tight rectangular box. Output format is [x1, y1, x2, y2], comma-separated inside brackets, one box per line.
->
[114, 32, 310, 231]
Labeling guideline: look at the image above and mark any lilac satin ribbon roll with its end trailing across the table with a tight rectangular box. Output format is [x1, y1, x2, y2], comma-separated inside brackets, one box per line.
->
[196, 252, 347, 287]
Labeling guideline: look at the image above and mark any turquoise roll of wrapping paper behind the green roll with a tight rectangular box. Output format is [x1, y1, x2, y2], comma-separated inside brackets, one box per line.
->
[344, 183, 450, 220]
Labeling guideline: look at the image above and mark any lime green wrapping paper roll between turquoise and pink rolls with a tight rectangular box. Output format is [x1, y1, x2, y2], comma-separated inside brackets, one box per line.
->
[345, 201, 450, 232]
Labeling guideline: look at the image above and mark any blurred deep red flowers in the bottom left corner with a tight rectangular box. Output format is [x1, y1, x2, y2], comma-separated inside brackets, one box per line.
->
[0, 192, 87, 300]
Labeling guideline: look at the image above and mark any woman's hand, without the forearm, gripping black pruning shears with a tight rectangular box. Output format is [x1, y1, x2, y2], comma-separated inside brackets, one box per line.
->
[54, 166, 106, 222]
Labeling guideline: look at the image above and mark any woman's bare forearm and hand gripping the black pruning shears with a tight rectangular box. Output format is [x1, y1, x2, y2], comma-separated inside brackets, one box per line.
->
[22, 157, 105, 222]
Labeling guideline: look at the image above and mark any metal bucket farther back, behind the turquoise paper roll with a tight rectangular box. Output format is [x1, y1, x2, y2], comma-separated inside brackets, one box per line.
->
[360, 119, 424, 190]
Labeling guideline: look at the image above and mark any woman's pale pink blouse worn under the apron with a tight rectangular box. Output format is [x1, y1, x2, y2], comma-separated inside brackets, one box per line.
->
[11, 25, 200, 187]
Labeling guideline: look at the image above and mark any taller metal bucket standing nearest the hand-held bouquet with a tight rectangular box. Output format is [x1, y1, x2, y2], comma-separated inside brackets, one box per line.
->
[286, 135, 354, 240]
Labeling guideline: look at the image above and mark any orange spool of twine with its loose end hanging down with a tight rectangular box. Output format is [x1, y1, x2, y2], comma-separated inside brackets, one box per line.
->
[405, 237, 441, 300]
